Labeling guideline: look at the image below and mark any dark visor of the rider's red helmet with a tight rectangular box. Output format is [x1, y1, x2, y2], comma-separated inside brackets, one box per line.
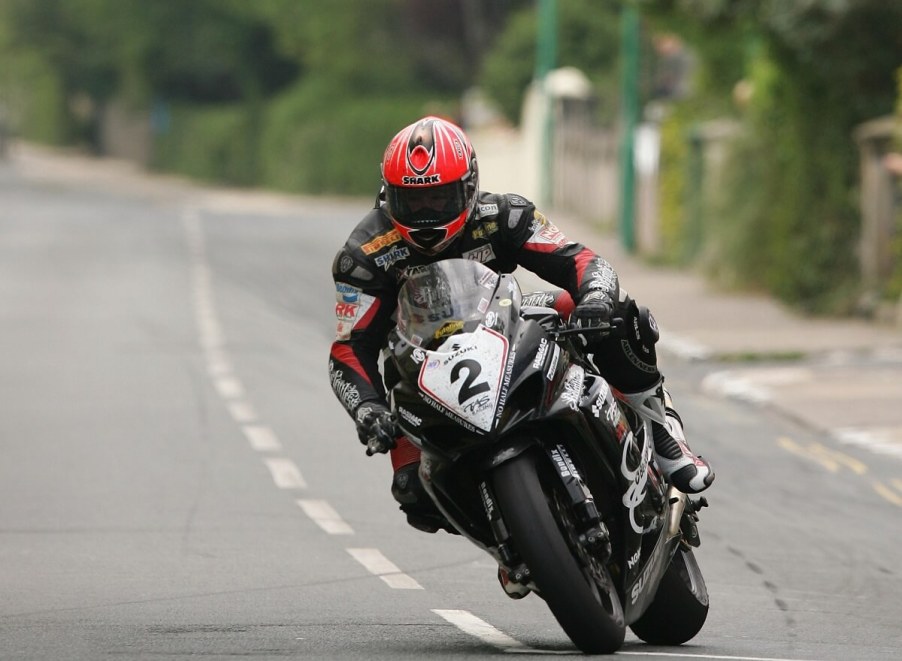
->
[385, 181, 468, 229]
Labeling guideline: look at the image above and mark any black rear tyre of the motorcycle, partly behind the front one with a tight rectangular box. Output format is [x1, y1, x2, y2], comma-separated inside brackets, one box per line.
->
[630, 549, 708, 645]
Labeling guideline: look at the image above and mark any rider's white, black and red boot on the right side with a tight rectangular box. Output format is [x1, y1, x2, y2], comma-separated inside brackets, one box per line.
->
[623, 379, 714, 493]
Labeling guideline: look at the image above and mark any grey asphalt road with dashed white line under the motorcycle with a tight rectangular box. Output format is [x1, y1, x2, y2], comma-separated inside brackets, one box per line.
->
[0, 152, 902, 661]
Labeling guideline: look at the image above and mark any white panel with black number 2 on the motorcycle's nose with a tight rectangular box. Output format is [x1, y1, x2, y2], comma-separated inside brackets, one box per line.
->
[419, 326, 508, 431]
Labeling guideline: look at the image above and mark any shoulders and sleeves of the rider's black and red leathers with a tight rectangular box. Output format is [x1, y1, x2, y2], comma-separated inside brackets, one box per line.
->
[329, 192, 619, 428]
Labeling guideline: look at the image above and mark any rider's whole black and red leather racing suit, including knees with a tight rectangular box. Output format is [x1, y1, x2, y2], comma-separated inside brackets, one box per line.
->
[329, 192, 661, 525]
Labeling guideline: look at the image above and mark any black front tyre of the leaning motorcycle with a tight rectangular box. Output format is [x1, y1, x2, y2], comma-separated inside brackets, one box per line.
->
[493, 452, 626, 654]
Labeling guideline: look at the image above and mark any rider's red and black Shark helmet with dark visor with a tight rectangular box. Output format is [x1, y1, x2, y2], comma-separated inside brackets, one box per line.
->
[382, 117, 479, 255]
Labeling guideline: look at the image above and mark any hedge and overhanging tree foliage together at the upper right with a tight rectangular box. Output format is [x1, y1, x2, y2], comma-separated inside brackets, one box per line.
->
[649, 0, 902, 311]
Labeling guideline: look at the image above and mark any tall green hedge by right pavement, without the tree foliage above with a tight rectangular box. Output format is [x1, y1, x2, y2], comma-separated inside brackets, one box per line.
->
[712, 51, 859, 313]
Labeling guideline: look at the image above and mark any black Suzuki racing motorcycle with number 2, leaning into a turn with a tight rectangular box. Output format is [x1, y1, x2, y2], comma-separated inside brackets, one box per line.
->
[378, 259, 708, 653]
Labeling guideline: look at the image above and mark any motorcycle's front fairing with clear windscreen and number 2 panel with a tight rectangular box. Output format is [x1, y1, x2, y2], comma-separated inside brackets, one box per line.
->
[389, 260, 521, 448]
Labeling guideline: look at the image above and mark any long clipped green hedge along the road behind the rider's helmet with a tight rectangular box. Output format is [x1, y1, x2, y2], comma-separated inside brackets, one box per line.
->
[154, 80, 460, 195]
